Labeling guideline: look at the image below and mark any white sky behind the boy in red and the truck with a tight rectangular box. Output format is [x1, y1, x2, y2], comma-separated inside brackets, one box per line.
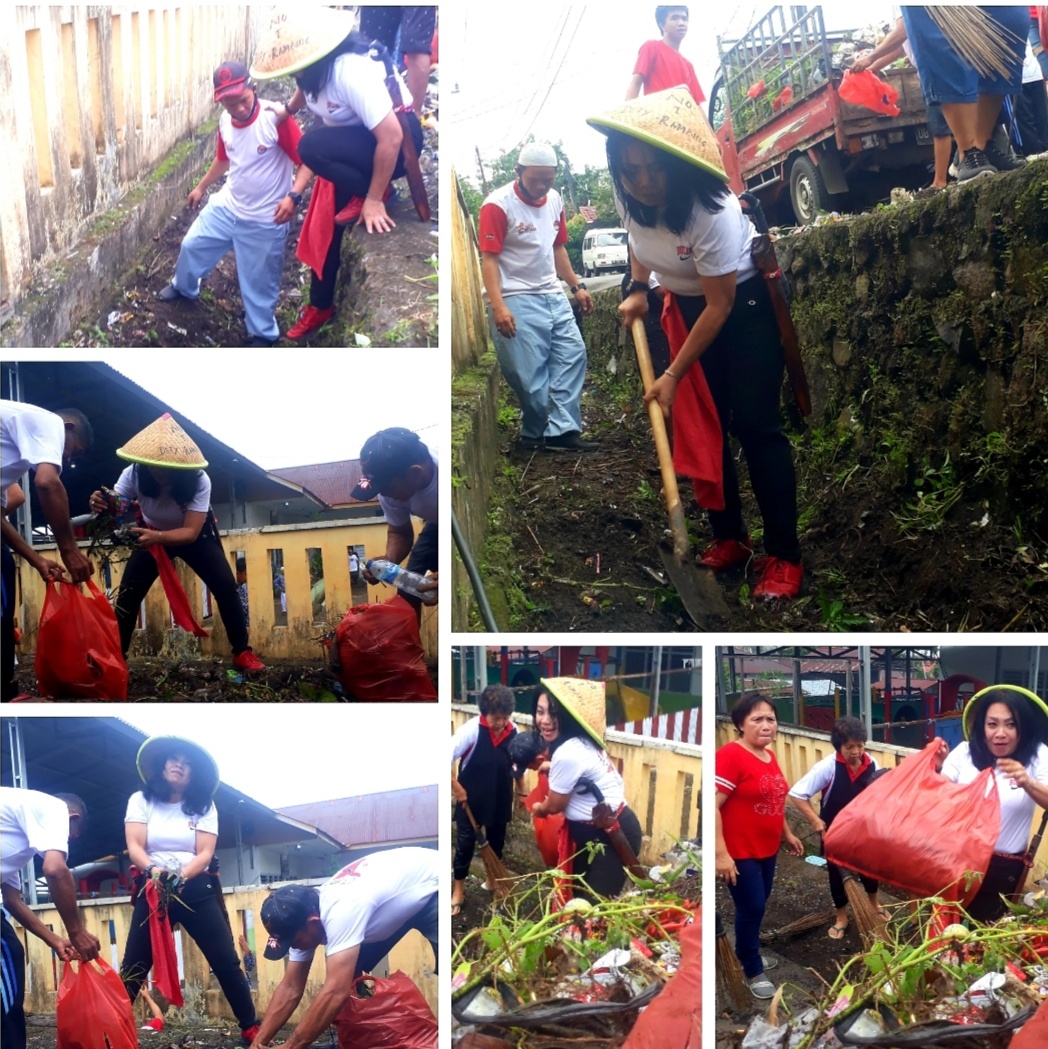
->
[441, 0, 892, 175]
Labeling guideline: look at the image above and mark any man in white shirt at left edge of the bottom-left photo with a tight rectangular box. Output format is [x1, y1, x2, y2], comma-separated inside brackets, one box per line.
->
[0, 787, 101, 1049]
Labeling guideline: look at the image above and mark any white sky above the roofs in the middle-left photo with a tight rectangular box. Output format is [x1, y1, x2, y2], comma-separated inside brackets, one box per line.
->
[105, 348, 450, 470]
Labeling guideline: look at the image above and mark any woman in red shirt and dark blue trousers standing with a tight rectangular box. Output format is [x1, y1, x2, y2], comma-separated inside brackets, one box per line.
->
[717, 692, 805, 998]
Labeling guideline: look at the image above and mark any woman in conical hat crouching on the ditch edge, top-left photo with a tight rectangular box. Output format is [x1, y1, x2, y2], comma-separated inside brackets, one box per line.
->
[251, 7, 423, 339]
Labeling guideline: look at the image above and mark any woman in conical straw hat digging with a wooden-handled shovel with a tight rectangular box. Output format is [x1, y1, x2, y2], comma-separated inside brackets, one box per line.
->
[589, 88, 804, 600]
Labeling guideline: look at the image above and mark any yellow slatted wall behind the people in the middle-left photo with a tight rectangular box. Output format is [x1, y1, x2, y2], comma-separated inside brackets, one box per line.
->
[19, 518, 439, 661]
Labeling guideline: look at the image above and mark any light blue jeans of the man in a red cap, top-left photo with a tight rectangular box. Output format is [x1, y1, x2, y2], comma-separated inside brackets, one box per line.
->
[171, 201, 287, 341]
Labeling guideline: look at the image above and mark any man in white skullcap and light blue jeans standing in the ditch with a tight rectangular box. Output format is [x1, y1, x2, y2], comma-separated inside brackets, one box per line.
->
[479, 142, 597, 451]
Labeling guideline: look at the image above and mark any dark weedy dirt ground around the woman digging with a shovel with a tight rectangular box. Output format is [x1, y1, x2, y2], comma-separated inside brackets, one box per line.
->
[484, 331, 1048, 633]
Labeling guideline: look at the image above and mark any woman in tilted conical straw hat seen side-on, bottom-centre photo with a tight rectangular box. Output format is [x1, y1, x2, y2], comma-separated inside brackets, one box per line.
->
[531, 678, 641, 896]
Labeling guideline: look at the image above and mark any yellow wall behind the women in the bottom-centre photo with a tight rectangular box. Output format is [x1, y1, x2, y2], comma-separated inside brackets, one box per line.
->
[451, 705, 702, 863]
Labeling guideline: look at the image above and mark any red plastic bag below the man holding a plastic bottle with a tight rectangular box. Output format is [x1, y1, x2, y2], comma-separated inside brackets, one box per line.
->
[331, 595, 436, 702]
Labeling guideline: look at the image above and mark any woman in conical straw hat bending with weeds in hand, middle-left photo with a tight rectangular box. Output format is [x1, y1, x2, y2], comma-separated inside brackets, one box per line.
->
[90, 412, 265, 670]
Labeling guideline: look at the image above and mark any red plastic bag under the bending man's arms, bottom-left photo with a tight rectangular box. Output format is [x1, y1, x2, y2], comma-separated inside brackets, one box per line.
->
[335, 972, 436, 1049]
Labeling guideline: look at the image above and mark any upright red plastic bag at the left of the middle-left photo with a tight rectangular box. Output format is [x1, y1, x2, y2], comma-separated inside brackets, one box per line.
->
[37, 580, 127, 700]
